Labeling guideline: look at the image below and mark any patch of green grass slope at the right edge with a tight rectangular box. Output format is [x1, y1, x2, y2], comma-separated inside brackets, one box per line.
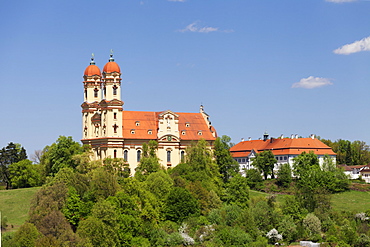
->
[332, 190, 370, 213]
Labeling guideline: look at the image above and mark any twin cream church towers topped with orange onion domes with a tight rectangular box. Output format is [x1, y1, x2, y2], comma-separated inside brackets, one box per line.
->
[81, 54, 123, 159]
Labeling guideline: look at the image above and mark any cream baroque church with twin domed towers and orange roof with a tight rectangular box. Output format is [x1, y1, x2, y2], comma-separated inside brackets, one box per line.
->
[81, 54, 217, 173]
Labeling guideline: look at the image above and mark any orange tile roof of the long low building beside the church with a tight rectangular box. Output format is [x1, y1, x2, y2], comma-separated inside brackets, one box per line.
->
[230, 138, 336, 157]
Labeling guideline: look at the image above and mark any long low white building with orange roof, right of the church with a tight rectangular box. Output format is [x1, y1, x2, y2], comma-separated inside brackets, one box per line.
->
[230, 133, 336, 174]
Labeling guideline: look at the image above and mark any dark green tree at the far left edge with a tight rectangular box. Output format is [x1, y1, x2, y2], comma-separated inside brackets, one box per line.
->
[0, 142, 27, 189]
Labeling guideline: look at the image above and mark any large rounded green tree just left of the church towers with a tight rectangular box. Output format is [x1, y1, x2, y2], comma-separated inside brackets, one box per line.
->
[41, 136, 84, 175]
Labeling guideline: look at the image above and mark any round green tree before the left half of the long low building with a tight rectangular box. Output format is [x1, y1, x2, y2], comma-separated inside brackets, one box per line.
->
[252, 150, 277, 180]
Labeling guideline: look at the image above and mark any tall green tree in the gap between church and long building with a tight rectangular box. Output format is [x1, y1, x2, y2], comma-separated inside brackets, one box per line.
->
[213, 135, 239, 183]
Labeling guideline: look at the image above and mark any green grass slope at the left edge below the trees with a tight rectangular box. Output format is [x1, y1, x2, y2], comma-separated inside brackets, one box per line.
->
[0, 187, 40, 232]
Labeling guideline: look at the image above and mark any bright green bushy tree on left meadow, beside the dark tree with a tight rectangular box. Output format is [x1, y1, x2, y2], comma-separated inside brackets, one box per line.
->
[8, 159, 42, 188]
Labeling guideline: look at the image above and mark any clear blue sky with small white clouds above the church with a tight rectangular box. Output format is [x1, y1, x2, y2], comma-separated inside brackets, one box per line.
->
[0, 0, 370, 155]
